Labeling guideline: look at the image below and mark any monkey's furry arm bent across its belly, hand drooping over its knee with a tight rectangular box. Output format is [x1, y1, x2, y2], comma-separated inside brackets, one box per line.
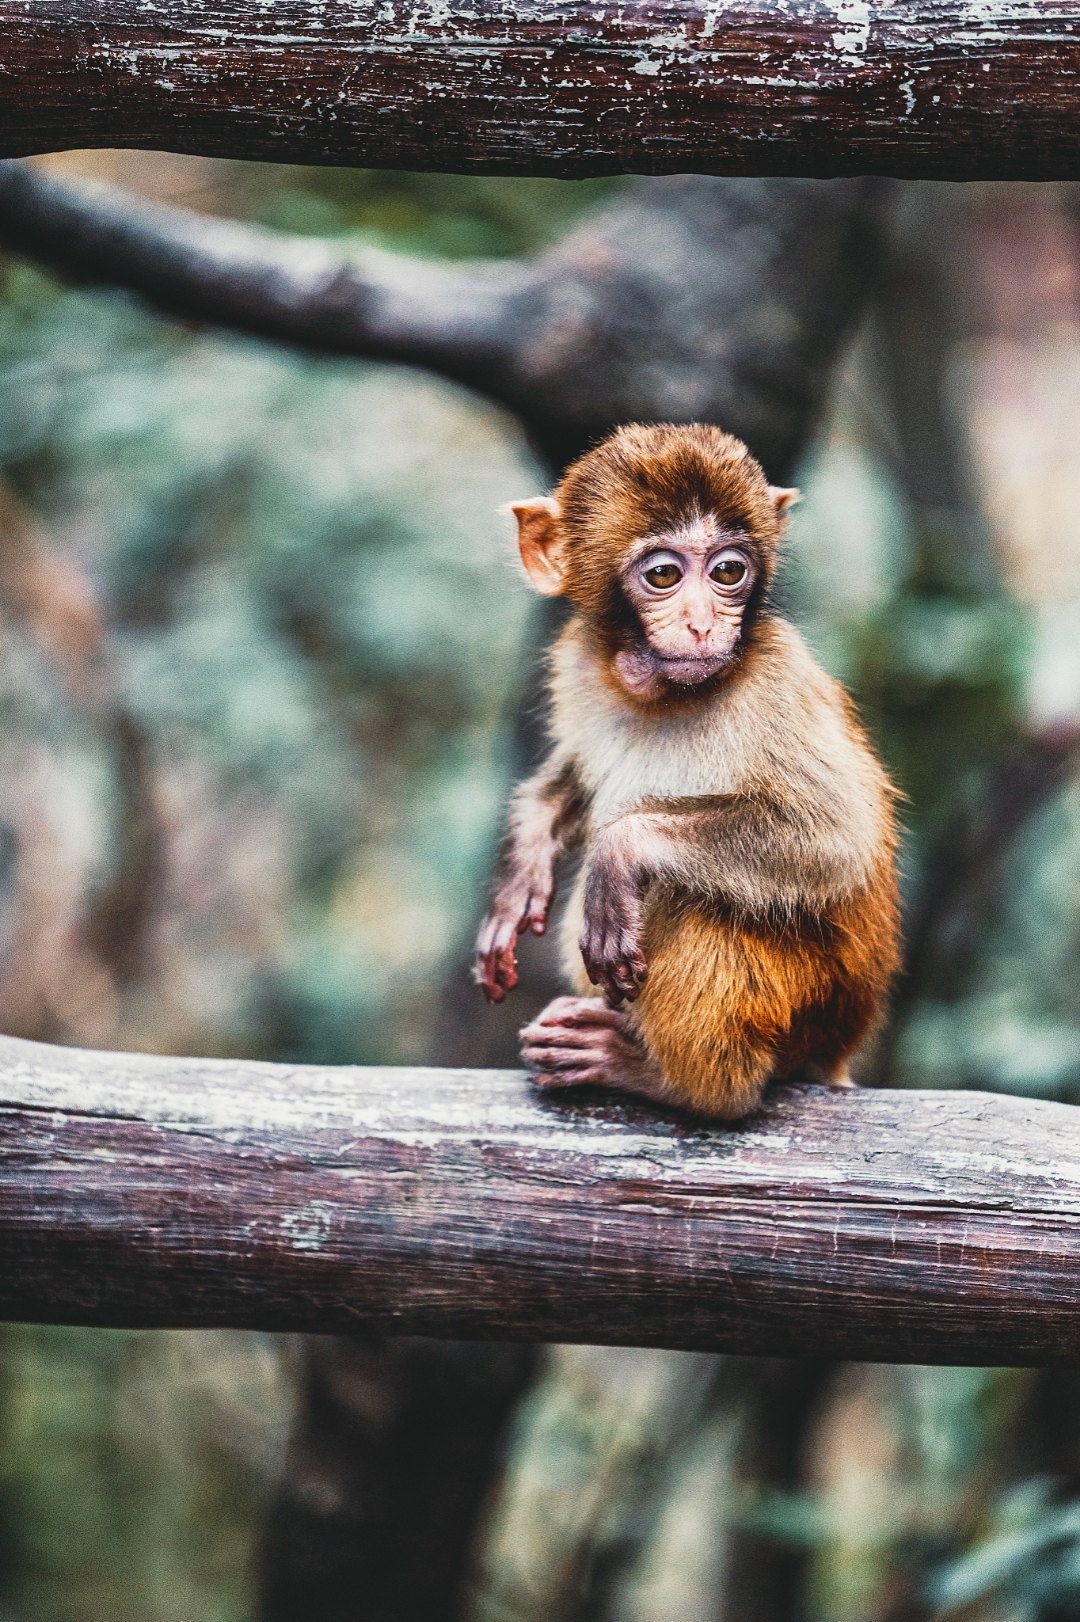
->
[579, 795, 869, 1002]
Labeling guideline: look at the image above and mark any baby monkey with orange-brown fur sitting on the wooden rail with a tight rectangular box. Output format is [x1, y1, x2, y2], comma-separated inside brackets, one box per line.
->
[477, 425, 898, 1119]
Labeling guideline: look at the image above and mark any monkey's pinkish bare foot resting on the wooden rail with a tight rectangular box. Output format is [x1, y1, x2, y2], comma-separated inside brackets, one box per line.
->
[519, 998, 671, 1103]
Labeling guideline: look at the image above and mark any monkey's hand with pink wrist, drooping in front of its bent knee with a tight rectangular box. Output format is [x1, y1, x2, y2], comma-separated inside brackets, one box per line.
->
[577, 817, 649, 1006]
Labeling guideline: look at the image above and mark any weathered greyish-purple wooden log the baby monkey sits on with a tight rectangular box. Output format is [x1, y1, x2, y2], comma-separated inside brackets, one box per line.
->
[0, 1038, 1080, 1364]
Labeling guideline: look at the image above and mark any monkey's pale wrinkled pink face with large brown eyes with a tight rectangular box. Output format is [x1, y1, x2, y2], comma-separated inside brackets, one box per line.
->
[613, 514, 759, 699]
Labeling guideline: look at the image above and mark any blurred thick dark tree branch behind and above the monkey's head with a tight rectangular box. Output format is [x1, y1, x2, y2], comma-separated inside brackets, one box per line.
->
[0, 164, 881, 477]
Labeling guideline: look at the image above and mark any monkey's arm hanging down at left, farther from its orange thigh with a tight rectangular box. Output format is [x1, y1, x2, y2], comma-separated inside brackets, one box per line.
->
[474, 753, 587, 1002]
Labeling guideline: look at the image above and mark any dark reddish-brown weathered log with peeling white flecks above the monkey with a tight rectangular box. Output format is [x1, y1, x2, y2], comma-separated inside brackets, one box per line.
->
[0, 0, 1080, 180]
